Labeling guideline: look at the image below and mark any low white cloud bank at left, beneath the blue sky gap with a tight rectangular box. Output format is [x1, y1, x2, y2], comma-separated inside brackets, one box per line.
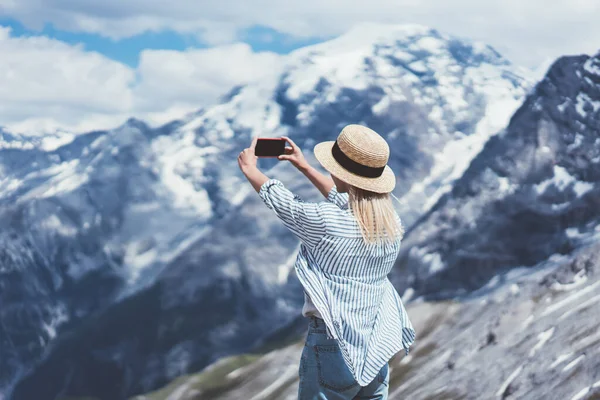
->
[0, 27, 280, 133]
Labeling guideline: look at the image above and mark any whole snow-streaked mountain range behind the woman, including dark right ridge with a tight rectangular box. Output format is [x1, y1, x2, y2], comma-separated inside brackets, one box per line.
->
[0, 25, 600, 400]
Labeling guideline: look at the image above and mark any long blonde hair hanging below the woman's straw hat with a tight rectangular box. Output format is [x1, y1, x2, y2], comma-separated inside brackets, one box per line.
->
[347, 184, 404, 244]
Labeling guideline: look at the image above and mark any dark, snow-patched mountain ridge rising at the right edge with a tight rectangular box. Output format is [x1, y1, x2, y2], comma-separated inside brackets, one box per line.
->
[395, 50, 600, 298]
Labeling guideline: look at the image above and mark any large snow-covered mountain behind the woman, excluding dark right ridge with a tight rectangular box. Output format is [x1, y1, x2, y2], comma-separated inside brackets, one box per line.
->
[0, 25, 533, 400]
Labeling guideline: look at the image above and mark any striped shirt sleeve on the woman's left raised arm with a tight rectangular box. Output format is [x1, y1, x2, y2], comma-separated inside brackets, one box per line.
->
[258, 179, 325, 249]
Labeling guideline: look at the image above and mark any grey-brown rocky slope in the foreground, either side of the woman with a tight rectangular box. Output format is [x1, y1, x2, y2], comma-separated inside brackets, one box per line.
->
[132, 239, 600, 400]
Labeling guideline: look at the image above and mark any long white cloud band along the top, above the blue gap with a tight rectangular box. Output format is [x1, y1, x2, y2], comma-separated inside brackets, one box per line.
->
[0, 0, 600, 67]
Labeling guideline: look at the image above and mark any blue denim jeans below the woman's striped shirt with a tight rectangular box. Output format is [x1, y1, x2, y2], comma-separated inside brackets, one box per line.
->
[298, 316, 390, 400]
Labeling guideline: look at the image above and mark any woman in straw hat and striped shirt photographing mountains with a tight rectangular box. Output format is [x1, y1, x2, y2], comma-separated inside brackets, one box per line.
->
[238, 125, 415, 400]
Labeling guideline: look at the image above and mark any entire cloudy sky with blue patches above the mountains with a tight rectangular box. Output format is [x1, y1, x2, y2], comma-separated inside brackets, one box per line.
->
[0, 0, 600, 133]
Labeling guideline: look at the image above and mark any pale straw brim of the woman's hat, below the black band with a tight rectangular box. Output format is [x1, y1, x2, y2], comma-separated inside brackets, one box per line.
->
[313, 140, 396, 193]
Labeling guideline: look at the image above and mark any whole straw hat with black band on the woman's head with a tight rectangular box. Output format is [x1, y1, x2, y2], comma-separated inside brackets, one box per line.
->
[313, 124, 396, 193]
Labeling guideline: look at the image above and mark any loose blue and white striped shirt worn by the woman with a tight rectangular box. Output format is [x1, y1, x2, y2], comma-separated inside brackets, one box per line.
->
[258, 179, 415, 386]
